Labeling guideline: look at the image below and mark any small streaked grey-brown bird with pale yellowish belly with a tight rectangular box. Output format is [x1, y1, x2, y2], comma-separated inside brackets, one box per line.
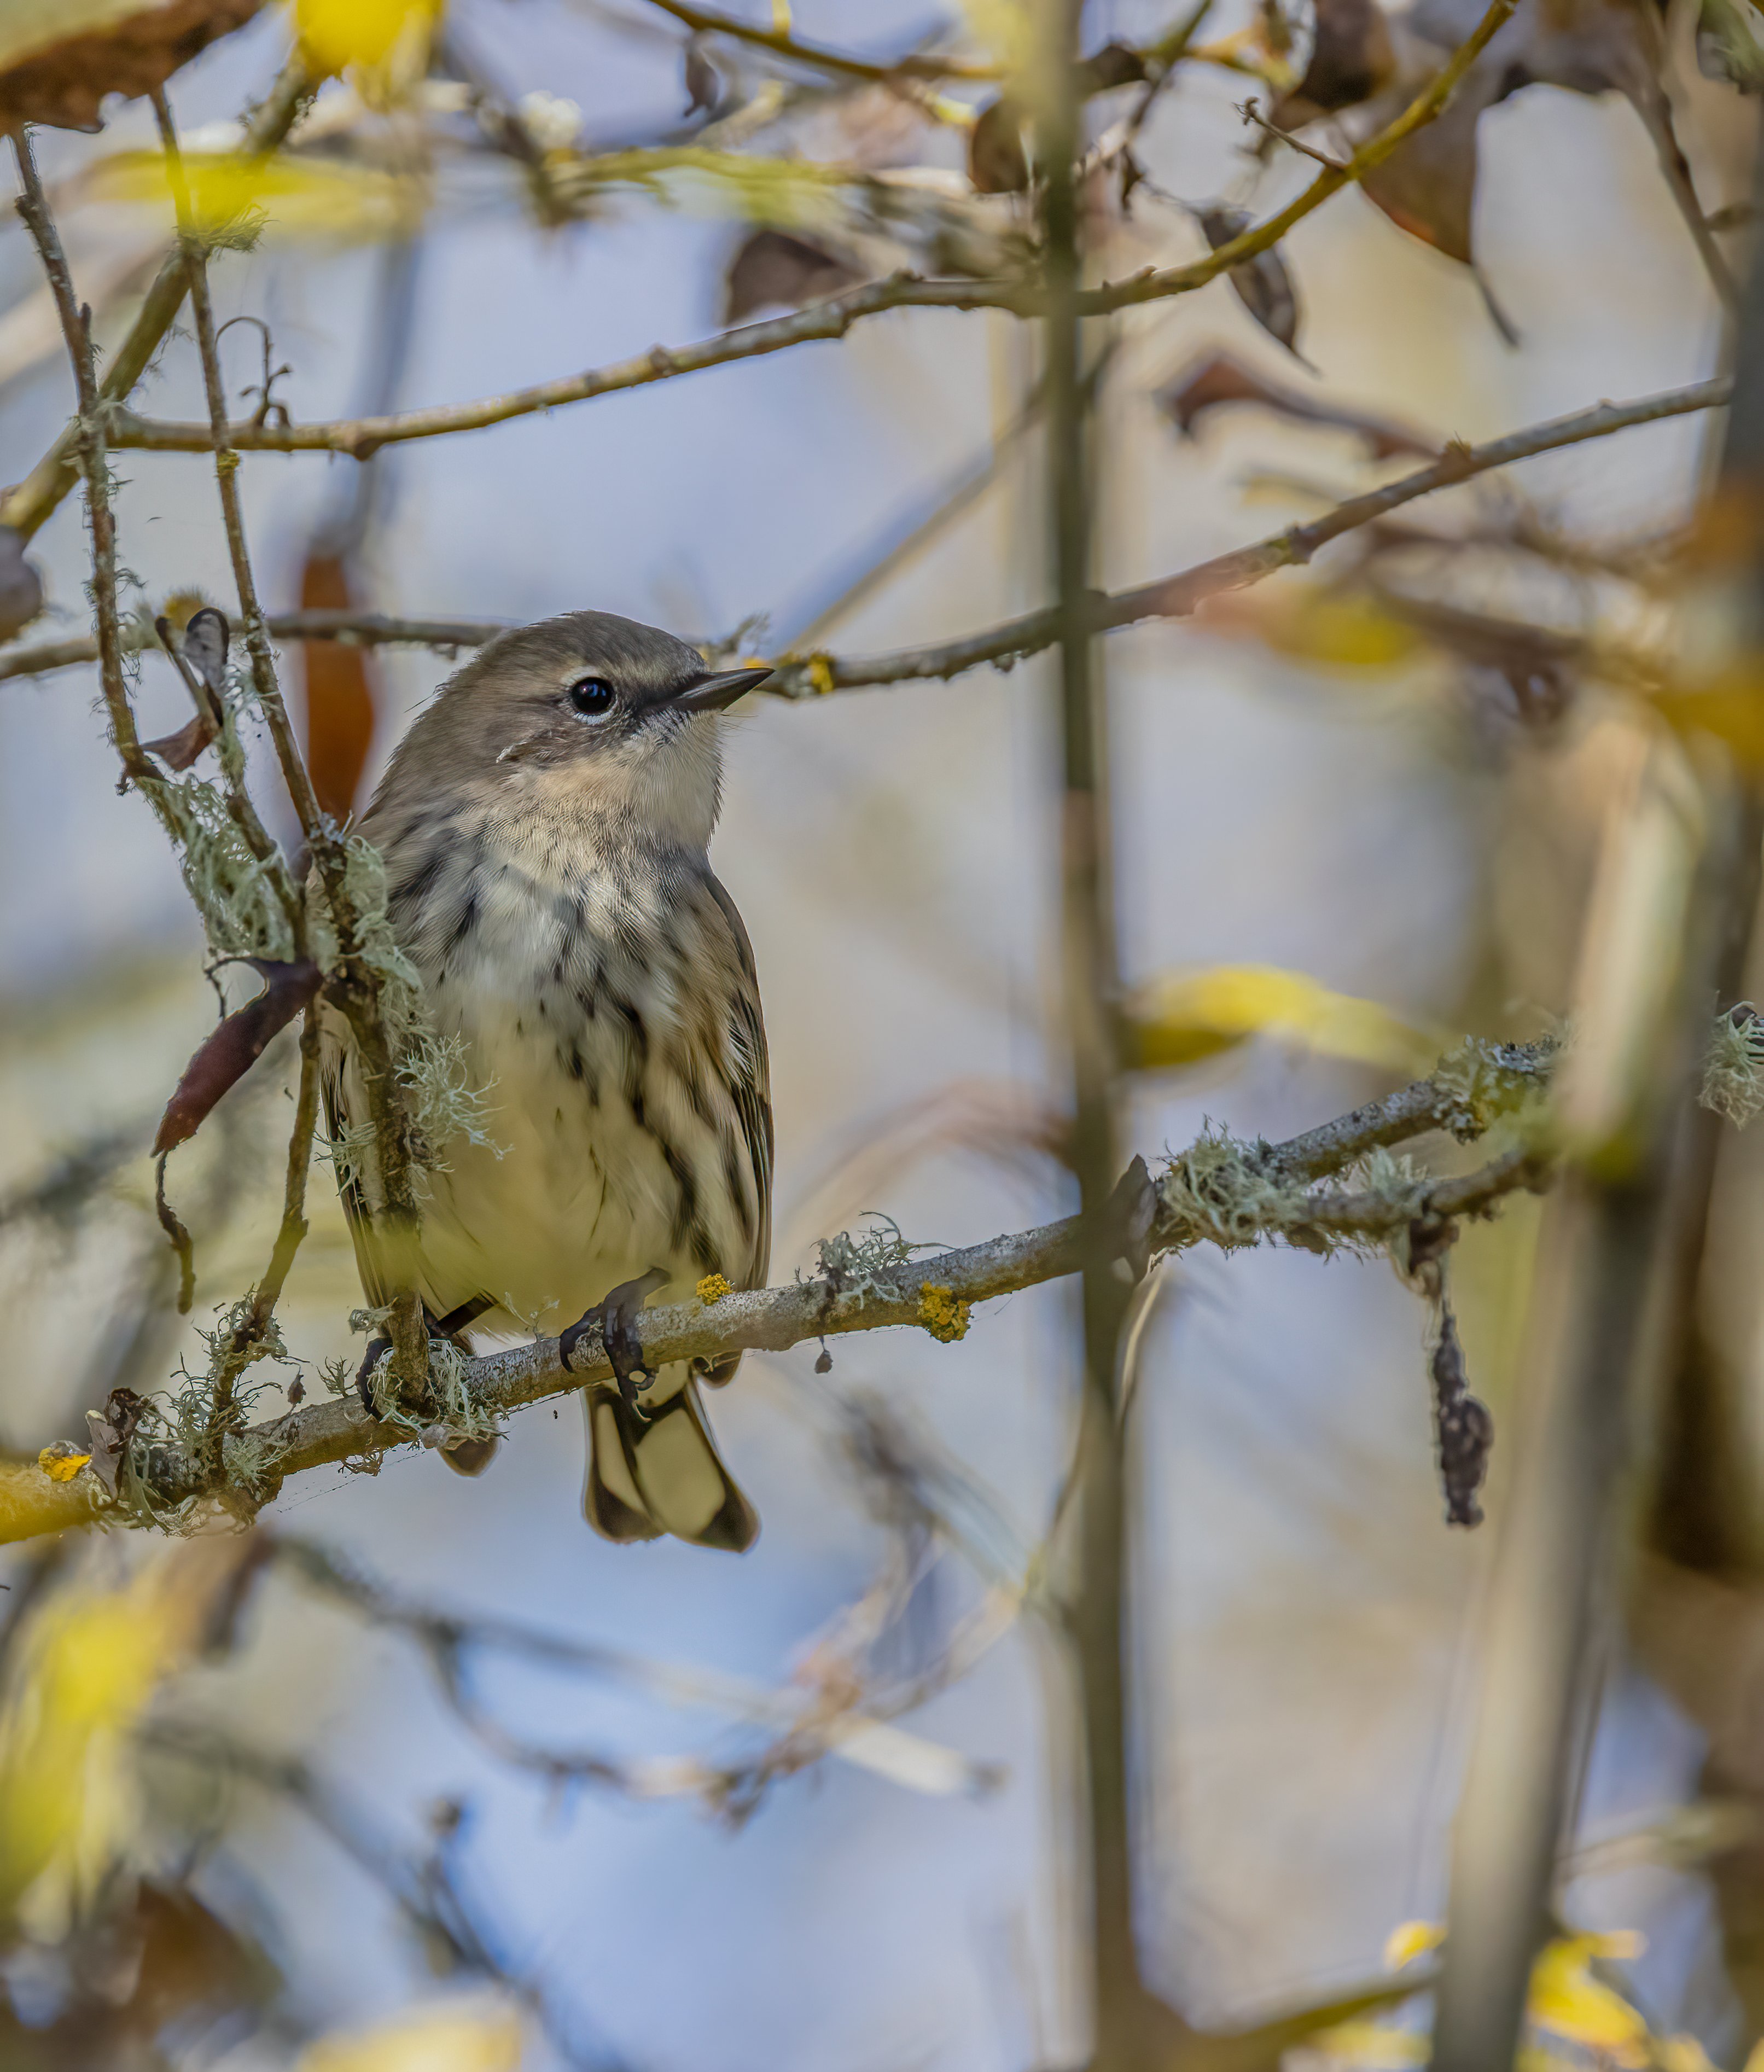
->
[321, 611, 771, 1550]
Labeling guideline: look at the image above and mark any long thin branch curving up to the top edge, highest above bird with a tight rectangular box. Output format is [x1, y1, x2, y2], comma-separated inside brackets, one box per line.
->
[103, 0, 1517, 466]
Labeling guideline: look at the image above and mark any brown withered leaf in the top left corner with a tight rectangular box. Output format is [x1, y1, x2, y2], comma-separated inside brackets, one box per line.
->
[0, 0, 263, 131]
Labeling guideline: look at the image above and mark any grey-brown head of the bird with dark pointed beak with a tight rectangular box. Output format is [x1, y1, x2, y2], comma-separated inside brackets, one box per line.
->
[381, 611, 771, 847]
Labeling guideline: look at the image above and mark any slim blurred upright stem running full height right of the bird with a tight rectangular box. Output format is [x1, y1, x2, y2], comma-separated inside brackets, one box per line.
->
[1037, 0, 1157, 2072]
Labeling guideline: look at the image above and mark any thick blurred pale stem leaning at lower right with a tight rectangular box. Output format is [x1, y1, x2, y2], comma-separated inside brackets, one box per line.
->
[1433, 746, 1741, 2072]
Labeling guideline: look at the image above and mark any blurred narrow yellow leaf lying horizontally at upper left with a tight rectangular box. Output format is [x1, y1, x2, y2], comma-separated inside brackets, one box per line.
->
[91, 152, 425, 238]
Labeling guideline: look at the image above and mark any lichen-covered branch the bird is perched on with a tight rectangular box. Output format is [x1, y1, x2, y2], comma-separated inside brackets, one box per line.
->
[0, 1042, 1552, 1541]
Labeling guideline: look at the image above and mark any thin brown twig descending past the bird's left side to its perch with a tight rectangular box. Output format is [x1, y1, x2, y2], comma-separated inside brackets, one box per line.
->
[153, 87, 429, 1390]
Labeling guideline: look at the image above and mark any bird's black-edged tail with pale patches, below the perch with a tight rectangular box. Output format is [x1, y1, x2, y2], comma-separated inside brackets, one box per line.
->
[583, 1361, 759, 1554]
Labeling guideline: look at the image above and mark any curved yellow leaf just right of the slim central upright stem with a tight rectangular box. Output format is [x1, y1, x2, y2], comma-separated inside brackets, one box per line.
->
[1126, 963, 1449, 1075]
